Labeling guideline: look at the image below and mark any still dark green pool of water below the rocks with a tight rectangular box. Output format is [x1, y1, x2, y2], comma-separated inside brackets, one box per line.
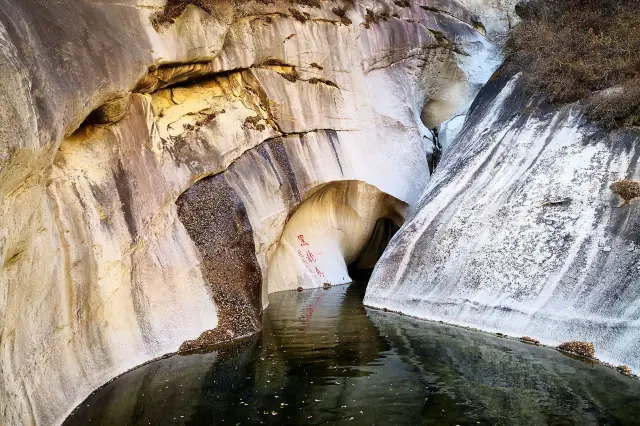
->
[65, 284, 640, 425]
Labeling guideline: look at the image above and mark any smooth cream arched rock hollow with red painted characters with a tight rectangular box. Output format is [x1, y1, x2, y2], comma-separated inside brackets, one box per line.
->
[267, 180, 407, 293]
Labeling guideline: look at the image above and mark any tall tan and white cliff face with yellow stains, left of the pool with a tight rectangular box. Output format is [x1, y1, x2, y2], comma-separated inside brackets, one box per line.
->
[0, 0, 504, 424]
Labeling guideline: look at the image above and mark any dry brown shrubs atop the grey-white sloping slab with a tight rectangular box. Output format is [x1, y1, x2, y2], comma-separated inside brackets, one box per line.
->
[505, 0, 640, 127]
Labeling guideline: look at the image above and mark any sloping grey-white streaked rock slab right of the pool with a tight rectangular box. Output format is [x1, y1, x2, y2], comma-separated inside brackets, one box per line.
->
[365, 77, 640, 369]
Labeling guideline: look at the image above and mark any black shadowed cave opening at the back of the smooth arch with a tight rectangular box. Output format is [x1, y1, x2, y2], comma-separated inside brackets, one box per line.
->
[347, 217, 400, 283]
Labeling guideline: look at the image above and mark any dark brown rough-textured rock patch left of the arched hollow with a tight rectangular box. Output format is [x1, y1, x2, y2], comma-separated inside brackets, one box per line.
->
[176, 174, 262, 351]
